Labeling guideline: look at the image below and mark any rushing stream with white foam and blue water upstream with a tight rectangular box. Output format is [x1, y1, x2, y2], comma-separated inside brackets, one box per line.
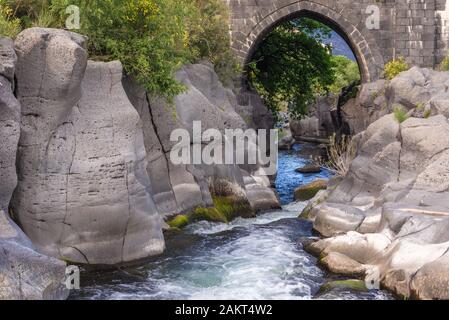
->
[71, 145, 391, 300]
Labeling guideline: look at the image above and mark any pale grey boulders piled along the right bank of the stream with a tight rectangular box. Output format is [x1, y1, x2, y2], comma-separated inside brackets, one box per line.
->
[300, 68, 449, 299]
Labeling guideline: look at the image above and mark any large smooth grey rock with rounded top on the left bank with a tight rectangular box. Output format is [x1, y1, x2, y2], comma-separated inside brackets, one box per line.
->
[12, 29, 164, 264]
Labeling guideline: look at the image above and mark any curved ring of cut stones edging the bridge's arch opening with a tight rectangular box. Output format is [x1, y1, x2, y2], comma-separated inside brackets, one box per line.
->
[232, 1, 385, 83]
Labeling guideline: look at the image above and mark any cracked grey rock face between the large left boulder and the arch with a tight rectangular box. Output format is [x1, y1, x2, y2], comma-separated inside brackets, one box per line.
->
[123, 63, 279, 218]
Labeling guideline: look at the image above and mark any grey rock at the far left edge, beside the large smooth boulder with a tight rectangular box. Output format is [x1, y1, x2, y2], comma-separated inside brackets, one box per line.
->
[0, 34, 68, 300]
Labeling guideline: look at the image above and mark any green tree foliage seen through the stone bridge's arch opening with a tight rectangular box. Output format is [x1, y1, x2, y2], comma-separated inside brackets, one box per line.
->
[248, 18, 360, 118]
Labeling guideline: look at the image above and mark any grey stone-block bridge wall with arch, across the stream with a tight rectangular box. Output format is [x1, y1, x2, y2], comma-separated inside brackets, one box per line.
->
[223, 0, 449, 82]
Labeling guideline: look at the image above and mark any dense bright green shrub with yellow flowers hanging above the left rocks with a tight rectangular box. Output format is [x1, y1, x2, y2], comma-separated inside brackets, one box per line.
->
[52, 0, 195, 98]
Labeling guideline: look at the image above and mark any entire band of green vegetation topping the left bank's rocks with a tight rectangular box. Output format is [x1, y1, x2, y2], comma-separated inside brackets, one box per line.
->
[0, 0, 238, 99]
